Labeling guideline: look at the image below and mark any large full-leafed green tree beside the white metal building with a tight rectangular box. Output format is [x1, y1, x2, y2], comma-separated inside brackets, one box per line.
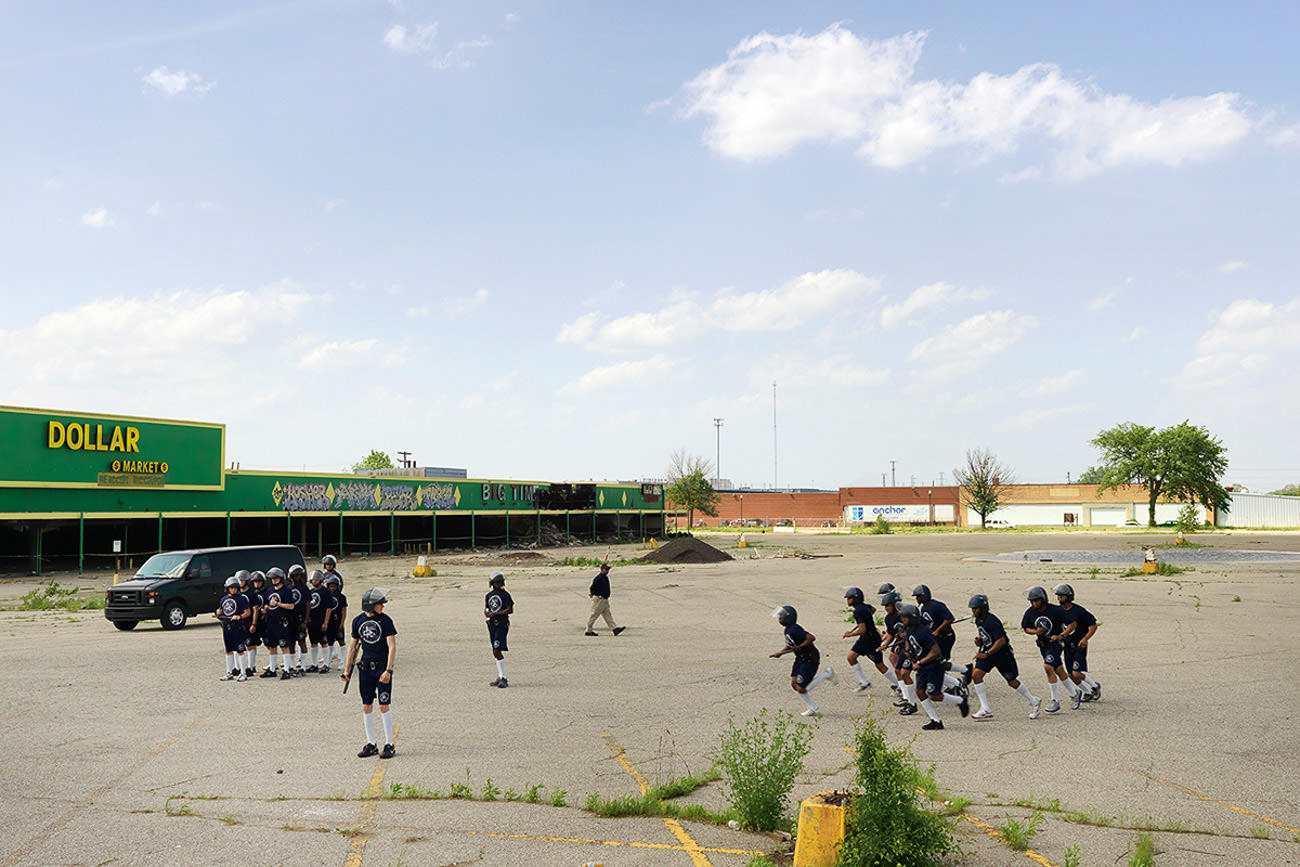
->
[1092, 420, 1231, 526]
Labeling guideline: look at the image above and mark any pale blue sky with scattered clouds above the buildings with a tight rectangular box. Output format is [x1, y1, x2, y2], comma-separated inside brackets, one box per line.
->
[0, 0, 1300, 490]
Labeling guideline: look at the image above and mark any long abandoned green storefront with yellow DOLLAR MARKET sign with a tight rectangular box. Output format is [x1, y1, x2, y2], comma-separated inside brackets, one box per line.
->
[0, 407, 672, 573]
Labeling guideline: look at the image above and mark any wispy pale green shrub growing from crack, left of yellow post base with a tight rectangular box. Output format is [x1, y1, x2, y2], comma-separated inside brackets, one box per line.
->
[712, 707, 813, 831]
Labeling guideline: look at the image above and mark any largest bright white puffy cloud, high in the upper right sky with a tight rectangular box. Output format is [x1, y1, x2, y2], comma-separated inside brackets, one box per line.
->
[683, 25, 1253, 179]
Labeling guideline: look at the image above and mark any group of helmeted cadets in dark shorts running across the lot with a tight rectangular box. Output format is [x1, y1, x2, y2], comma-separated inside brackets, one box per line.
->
[772, 584, 1101, 731]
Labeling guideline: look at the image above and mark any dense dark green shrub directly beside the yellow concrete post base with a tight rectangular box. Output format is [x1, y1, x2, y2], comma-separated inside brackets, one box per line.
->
[836, 715, 956, 867]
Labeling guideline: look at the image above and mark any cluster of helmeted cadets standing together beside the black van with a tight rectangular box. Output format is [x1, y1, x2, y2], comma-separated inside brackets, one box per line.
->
[216, 554, 347, 681]
